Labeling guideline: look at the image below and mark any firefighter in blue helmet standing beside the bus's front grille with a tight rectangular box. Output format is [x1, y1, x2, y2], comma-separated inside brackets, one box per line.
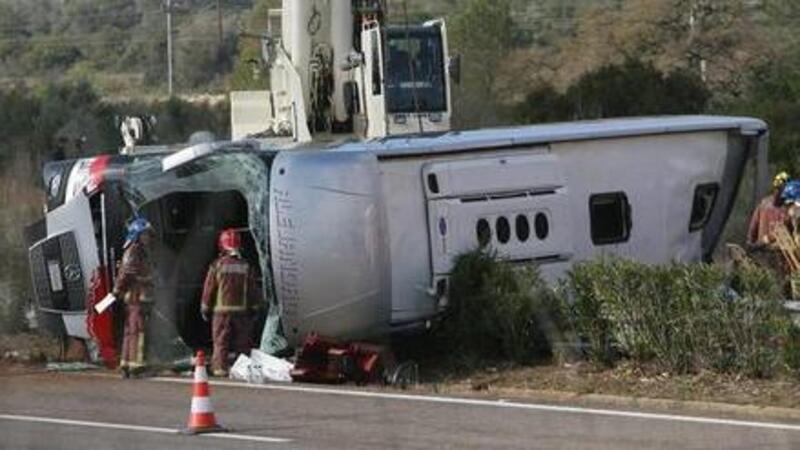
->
[112, 217, 154, 378]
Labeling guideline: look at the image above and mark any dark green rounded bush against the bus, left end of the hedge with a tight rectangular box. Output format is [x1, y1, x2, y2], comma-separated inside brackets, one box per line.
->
[441, 250, 558, 363]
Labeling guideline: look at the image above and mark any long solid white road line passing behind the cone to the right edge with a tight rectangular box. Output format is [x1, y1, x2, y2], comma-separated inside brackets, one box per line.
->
[150, 377, 800, 431]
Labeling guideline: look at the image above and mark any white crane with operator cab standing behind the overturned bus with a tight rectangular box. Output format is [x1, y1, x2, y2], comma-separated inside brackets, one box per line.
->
[231, 0, 459, 143]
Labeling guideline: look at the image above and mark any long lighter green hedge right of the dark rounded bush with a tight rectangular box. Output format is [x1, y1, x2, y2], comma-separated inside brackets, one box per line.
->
[560, 259, 789, 377]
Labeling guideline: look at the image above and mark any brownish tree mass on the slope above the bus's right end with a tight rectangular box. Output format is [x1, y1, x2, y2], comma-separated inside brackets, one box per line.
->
[554, 0, 777, 102]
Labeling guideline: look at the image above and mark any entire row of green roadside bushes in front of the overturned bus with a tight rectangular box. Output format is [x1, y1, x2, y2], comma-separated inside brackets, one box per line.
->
[440, 251, 788, 378]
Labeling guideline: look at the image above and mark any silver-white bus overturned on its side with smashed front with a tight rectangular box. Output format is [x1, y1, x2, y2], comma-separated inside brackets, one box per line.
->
[28, 116, 767, 365]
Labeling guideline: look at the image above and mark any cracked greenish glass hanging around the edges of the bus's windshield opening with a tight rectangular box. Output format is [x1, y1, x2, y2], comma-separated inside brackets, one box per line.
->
[111, 149, 286, 361]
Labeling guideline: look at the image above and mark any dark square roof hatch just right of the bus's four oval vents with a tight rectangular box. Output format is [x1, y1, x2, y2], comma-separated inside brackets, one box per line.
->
[589, 192, 632, 245]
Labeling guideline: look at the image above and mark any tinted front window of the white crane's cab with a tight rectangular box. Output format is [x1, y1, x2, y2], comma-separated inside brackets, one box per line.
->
[386, 27, 447, 113]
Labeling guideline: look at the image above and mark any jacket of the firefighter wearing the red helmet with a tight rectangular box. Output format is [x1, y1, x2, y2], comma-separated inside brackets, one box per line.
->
[200, 253, 261, 314]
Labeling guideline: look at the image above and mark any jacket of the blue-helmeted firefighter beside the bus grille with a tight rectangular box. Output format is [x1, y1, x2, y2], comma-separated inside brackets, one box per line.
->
[114, 241, 153, 304]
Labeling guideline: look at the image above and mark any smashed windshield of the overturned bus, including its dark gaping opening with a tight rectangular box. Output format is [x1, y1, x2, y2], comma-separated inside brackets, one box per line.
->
[120, 151, 283, 356]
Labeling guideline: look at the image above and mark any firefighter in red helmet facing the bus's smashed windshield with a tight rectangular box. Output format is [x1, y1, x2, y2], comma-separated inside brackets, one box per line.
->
[200, 229, 261, 377]
